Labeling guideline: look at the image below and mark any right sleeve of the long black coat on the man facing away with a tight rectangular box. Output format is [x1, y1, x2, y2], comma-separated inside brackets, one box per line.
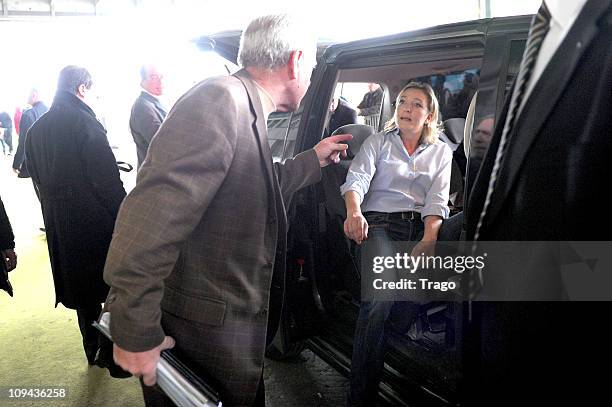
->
[81, 121, 125, 218]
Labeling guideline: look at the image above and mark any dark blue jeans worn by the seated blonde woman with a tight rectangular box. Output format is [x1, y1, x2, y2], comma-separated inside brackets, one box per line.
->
[347, 212, 424, 407]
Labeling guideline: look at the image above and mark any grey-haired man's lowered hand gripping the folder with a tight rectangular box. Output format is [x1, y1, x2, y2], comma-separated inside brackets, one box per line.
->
[113, 336, 175, 386]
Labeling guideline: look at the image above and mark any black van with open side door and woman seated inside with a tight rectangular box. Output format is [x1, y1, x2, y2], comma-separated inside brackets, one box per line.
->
[200, 16, 531, 406]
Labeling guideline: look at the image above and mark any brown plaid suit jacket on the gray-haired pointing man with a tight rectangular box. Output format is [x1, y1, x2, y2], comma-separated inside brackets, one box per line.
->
[104, 71, 321, 406]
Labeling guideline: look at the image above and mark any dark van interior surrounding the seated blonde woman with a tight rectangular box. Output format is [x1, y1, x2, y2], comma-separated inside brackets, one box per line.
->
[280, 58, 481, 404]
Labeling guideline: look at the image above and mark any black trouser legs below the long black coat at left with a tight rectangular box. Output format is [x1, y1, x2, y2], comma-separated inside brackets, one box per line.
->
[76, 304, 113, 365]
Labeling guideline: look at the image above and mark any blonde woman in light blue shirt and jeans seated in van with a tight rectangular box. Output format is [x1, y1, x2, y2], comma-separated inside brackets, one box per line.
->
[341, 82, 452, 406]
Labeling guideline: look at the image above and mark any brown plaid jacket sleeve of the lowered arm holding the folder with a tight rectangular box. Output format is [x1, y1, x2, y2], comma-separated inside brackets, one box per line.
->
[104, 86, 238, 352]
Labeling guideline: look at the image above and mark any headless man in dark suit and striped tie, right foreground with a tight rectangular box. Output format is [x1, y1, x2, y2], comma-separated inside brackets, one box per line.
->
[467, 0, 612, 405]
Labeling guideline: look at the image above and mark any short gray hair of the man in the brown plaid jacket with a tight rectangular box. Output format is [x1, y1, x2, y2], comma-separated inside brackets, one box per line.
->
[238, 14, 316, 69]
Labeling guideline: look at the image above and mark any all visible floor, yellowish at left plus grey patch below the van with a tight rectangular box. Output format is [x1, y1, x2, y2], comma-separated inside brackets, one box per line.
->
[0, 151, 346, 407]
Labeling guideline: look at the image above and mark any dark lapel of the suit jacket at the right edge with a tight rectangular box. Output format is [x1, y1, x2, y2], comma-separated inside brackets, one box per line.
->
[485, 0, 612, 230]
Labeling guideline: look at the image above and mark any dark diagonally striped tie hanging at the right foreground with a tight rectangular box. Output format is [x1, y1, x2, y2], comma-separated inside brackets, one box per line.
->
[473, 2, 550, 244]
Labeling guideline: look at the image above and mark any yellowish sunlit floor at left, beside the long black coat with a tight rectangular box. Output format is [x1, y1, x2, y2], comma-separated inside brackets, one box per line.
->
[0, 151, 144, 407]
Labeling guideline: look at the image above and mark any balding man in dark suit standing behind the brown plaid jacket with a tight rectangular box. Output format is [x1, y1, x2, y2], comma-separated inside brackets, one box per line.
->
[130, 65, 166, 168]
